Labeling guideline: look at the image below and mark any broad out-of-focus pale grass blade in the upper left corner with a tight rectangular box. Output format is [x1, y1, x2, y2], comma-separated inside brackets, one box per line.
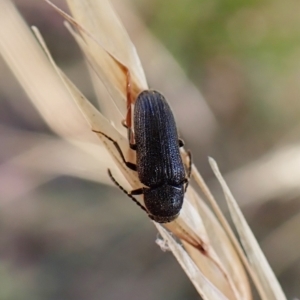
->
[0, 0, 95, 141]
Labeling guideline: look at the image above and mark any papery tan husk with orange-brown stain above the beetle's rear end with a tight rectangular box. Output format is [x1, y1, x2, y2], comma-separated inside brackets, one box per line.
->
[46, 0, 148, 124]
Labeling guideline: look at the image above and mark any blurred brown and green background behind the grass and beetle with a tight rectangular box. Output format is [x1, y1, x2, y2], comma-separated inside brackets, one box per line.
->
[0, 0, 300, 300]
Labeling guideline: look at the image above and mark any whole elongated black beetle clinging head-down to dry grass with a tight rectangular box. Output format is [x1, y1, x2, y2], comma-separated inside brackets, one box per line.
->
[96, 90, 191, 223]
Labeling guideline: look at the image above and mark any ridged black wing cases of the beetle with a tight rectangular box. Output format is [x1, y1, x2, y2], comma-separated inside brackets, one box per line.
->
[134, 90, 185, 187]
